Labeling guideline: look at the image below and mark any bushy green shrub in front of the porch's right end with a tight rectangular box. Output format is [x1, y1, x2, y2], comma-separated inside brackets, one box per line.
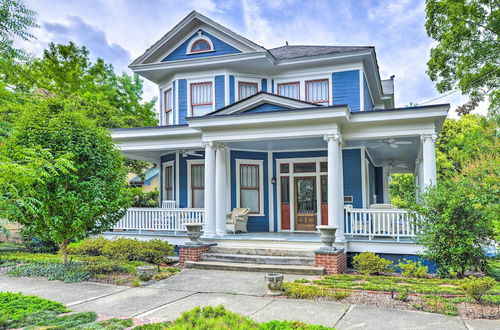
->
[409, 180, 498, 278]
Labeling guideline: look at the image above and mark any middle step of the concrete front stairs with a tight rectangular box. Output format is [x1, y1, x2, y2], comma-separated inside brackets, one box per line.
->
[201, 252, 314, 266]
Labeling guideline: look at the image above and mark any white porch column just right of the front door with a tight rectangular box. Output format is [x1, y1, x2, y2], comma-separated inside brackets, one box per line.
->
[324, 133, 344, 238]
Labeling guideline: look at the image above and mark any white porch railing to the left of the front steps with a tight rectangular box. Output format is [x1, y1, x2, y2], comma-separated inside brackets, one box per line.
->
[113, 207, 205, 232]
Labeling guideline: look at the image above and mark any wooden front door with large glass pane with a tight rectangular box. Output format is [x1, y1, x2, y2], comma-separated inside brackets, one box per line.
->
[295, 176, 316, 231]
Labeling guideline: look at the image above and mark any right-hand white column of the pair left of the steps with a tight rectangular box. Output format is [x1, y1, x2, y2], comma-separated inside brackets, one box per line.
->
[215, 143, 227, 235]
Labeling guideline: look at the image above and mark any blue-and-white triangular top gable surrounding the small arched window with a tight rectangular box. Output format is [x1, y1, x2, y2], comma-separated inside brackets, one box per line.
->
[131, 11, 266, 66]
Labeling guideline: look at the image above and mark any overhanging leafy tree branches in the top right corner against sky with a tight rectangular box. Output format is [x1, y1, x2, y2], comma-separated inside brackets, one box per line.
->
[425, 0, 500, 115]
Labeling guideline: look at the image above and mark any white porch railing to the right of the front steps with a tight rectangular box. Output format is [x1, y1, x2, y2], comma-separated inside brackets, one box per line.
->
[345, 207, 418, 241]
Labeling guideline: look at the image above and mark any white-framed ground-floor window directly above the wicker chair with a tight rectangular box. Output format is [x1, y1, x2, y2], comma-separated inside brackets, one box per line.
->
[237, 159, 263, 214]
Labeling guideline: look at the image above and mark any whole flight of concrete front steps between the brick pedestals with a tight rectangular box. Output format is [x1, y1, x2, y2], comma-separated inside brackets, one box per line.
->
[184, 246, 324, 275]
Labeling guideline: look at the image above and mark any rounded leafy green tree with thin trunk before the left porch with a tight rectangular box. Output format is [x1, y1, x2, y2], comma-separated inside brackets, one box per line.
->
[5, 96, 130, 263]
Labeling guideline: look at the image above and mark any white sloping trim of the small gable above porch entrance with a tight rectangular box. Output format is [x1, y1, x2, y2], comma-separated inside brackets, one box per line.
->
[207, 92, 321, 116]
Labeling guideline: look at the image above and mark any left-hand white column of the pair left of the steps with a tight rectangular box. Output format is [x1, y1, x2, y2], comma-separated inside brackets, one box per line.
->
[204, 142, 215, 235]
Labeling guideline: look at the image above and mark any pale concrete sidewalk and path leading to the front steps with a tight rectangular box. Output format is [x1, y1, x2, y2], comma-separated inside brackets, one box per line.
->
[0, 269, 500, 330]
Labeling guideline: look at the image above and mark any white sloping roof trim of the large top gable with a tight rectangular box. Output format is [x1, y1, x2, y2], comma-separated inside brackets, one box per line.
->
[130, 10, 266, 66]
